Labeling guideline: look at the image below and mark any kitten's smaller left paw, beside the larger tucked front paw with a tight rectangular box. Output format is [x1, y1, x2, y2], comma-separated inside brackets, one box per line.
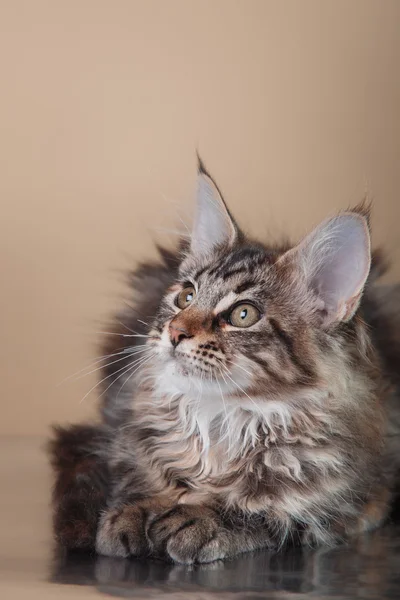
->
[96, 505, 149, 558]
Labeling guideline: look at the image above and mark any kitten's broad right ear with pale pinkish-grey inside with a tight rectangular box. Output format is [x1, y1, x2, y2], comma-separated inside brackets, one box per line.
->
[283, 212, 371, 326]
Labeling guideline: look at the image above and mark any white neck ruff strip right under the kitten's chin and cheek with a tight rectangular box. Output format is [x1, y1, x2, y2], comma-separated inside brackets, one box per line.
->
[139, 372, 327, 458]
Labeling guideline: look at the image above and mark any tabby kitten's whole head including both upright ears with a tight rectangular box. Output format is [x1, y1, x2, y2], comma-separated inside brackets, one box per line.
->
[149, 164, 370, 397]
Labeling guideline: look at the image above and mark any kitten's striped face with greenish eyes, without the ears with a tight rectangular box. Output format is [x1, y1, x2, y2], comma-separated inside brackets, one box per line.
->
[151, 244, 316, 394]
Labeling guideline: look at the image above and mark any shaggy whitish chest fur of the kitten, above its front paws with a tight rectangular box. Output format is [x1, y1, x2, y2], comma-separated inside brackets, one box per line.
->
[135, 384, 320, 487]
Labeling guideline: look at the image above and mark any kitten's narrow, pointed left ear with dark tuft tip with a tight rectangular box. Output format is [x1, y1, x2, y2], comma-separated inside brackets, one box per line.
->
[190, 159, 238, 254]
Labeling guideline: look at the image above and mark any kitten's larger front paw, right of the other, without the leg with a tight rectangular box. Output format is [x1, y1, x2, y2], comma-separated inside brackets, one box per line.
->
[147, 504, 228, 564]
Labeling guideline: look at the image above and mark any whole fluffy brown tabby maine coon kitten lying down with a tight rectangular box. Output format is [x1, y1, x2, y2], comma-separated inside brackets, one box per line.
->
[50, 159, 400, 563]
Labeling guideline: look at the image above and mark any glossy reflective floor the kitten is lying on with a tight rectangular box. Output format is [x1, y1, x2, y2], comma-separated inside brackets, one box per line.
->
[0, 438, 400, 600]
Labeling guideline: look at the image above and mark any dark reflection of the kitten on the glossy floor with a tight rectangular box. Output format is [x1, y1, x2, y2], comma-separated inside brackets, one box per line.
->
[50, 521, 400, 600]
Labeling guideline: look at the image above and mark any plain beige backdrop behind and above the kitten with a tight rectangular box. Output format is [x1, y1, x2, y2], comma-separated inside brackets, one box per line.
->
[0, 0, 400, 433]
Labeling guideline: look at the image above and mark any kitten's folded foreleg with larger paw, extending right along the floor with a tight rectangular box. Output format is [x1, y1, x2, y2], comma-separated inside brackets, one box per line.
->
[147, 504, 274, 564]
